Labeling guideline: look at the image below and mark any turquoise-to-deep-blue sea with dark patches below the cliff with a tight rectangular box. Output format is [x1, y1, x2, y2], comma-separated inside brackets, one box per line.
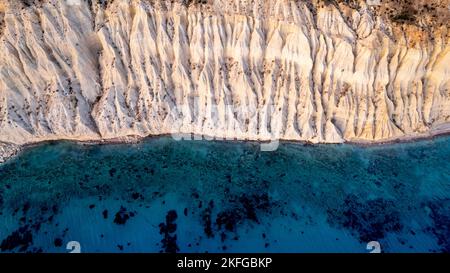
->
[0, 137, 450, 252]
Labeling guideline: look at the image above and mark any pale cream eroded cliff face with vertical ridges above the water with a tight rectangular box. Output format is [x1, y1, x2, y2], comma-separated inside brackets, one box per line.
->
[0, 0, 450, 155]
